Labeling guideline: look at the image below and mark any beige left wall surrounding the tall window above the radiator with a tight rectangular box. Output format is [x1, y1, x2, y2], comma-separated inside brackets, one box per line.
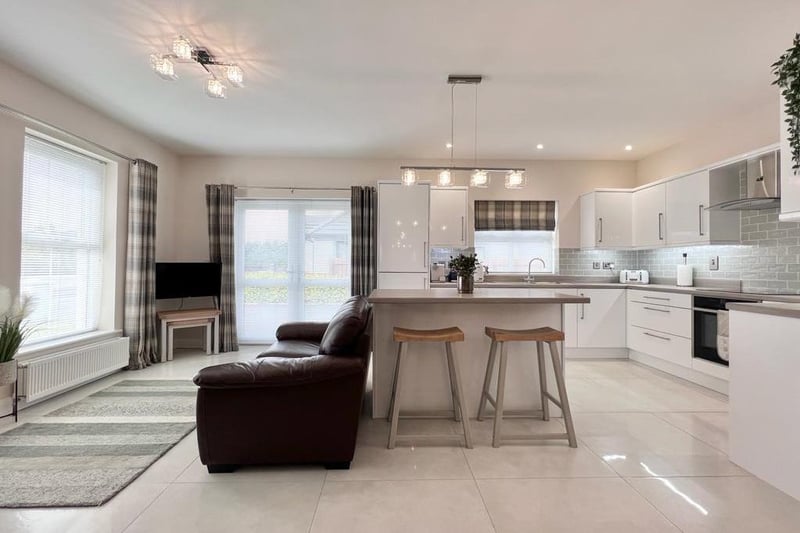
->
[0, 62, 179, 328]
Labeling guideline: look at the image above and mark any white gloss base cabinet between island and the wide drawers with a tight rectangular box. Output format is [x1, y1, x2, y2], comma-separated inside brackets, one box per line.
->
[558, 288, 626, 357]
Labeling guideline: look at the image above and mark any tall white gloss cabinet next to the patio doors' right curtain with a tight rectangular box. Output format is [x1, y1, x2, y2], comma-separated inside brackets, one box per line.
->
[378, 182, 431, 289]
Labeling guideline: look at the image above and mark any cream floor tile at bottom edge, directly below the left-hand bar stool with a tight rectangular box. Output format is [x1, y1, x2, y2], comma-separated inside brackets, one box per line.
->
[311, 480, 494, 533]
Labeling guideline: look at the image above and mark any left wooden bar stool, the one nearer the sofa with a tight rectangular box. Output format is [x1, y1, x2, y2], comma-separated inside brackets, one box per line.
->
[388, 327, 472, 449]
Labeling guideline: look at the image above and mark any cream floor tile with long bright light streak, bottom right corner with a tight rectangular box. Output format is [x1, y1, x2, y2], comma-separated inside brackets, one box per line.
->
[628, 477, 800, 533]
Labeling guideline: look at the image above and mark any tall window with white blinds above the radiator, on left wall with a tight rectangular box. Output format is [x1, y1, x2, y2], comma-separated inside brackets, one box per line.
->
[20, 136, 106, 343]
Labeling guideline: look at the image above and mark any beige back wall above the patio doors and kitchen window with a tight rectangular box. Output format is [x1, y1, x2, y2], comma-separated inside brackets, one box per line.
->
[175, 157, 636, 255]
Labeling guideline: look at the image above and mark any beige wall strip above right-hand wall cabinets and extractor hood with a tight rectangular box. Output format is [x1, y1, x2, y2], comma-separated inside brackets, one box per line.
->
[636, 97, 779, 185]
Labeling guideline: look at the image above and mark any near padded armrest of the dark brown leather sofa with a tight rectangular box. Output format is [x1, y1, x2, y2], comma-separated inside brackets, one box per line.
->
[193, 355, 366, 389]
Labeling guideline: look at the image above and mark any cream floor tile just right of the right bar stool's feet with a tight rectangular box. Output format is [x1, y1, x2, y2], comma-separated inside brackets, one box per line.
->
[575, 413, 748, 477]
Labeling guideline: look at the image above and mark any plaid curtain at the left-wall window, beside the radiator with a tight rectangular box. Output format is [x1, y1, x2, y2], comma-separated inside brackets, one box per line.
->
[124, 159, 159, 370]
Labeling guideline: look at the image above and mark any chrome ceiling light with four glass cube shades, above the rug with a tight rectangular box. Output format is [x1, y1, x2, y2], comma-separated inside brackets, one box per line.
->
[150, 35, 244, 98]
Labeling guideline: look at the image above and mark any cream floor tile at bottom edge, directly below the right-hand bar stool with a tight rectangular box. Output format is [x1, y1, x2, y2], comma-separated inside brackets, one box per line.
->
[478, 478, 679, 533]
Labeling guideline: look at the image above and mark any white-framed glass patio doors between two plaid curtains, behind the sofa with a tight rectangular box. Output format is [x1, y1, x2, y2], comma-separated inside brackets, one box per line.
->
[235, 200, 350, 343]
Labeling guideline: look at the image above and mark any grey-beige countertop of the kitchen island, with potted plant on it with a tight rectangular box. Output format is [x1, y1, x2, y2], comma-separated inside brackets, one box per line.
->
[369, 288, 590, 304]
